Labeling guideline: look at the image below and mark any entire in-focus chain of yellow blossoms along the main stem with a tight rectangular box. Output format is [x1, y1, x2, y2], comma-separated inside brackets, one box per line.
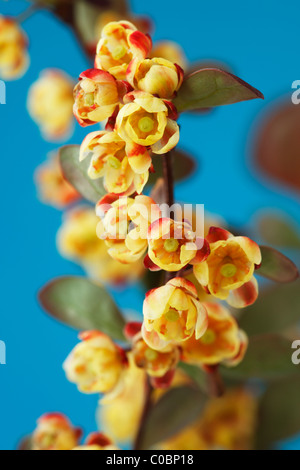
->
[64, 17, 261, 401]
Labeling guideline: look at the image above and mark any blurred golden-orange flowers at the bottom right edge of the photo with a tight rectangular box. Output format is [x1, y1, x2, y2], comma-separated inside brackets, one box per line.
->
[161, 389, 258, 450]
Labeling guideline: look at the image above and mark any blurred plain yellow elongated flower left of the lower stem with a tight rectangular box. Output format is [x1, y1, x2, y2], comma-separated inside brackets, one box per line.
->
[98, 354, 146, 443]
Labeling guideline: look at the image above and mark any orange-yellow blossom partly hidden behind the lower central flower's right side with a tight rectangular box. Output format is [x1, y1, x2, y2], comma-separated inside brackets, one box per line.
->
[182, 302, 248, 366]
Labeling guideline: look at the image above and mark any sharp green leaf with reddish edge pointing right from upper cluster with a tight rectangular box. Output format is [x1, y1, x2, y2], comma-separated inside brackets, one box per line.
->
[173, 68, 264, 112]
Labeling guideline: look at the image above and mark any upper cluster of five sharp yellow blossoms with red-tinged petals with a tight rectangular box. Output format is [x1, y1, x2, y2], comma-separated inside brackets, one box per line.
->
[74, 21, 183, 196]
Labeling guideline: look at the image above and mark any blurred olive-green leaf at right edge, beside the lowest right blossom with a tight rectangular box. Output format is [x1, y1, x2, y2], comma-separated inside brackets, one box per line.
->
[222, 334, 300, 380]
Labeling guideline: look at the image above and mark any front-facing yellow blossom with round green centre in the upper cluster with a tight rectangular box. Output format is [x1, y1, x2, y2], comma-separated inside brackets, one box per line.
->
[115, 90, 179, 154]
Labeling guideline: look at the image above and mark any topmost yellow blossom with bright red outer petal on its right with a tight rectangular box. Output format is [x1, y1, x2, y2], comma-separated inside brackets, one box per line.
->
[95, 21, 152, 80]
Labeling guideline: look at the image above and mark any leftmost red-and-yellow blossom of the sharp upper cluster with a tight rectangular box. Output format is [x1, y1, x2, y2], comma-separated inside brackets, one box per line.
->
[74, 69, 129, 126]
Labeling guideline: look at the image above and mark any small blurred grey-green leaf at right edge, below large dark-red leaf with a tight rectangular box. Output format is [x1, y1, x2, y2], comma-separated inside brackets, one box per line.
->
[258, 214, 300, 248]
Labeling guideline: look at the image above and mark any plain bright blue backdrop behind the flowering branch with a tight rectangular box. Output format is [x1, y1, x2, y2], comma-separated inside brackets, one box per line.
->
[0, 0, 300, 449]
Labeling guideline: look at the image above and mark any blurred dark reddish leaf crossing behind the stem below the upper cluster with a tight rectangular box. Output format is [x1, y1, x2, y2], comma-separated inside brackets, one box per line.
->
[148, 148, 197, 185]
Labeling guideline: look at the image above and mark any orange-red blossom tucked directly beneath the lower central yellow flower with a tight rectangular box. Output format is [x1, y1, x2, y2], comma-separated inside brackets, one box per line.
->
[132, 333, 179, 377]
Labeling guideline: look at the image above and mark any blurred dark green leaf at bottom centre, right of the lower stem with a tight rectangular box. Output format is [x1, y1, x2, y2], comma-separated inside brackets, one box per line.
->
[141, 387, 206, 450]
